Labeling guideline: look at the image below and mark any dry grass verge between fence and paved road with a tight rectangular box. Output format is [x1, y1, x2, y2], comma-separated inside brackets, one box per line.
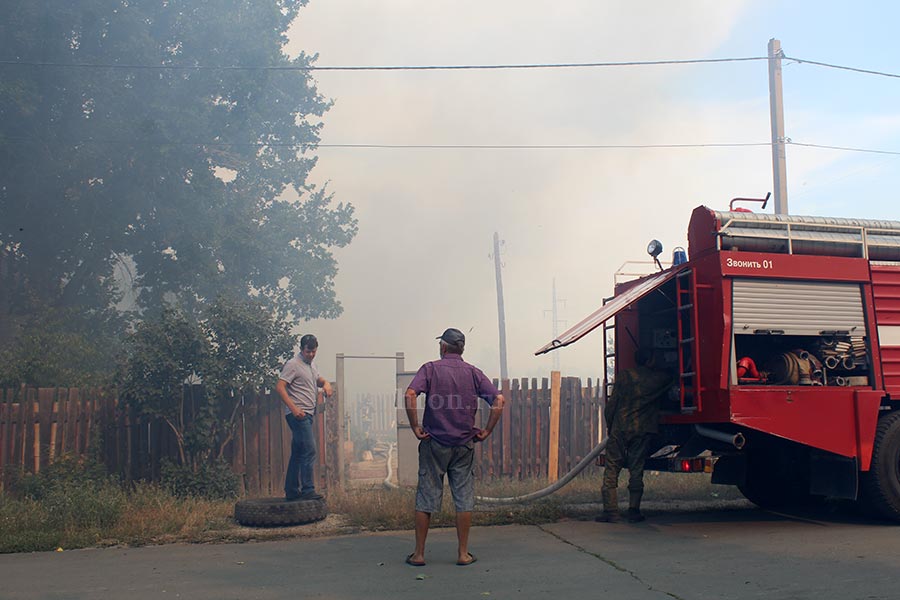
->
[0, 473, 741, 553]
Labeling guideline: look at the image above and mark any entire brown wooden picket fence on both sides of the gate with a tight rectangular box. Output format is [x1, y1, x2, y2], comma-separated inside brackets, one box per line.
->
[0, 377, 603, 496]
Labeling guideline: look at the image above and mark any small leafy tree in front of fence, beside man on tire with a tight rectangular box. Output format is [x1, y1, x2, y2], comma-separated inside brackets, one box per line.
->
[120, 298, 294, 473]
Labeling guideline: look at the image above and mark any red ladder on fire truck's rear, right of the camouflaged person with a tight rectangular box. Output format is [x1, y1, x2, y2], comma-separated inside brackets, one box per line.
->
[675, 269, 701, 413]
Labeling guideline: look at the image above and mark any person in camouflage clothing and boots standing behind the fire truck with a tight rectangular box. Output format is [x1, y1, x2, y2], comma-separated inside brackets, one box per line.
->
[596, 349, 673, 523]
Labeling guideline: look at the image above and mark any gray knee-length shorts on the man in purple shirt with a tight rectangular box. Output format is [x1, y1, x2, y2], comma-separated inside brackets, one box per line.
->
[416, 438, 475, 513]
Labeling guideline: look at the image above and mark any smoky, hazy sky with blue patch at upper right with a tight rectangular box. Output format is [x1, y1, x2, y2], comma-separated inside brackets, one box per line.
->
[282, 0, 900, 393]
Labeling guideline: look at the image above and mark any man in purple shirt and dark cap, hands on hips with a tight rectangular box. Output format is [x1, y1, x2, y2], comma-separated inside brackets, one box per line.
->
[406, 328, 503, 567]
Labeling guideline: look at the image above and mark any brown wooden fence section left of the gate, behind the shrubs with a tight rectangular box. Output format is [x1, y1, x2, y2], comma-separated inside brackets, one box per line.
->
[0, 387, 334, 496]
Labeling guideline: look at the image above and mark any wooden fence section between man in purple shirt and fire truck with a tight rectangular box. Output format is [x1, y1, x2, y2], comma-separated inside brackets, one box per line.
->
[475, 377, 604, 480]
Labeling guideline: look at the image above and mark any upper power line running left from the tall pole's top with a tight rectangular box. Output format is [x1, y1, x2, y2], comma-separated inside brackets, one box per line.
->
[0, 56, 768, 71]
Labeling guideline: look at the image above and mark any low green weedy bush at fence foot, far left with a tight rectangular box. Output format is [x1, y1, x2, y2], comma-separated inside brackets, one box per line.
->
[17, 458, 126, 528]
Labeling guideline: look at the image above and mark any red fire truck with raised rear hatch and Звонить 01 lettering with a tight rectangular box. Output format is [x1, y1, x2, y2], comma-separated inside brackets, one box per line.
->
[536, 206, 900, 520]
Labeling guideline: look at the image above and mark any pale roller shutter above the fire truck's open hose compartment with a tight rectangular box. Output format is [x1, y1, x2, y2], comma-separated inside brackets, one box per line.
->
[732, 279, 866, 336]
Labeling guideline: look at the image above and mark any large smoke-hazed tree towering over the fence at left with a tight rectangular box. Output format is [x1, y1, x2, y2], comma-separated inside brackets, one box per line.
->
[0, 0, 357, 352]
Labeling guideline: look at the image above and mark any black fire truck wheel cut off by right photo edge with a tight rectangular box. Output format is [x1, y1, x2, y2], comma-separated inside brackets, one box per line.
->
[861, 412, 900, 521]
